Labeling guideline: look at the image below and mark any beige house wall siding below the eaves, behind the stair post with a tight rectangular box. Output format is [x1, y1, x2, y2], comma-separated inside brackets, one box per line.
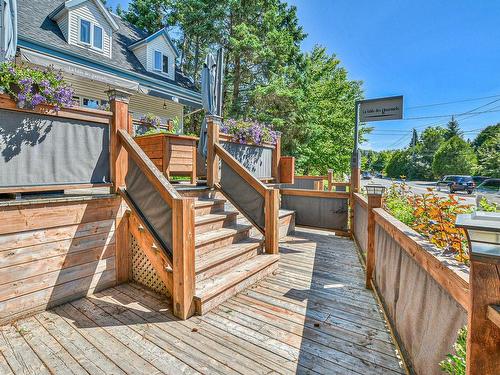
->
[64, 74, 184, 130]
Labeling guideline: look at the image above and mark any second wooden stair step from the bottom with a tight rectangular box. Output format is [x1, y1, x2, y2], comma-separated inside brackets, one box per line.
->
[195, 238, 264, 282]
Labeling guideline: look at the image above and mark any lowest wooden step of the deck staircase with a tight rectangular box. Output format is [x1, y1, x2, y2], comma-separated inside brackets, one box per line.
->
[194, 254, 279, 315]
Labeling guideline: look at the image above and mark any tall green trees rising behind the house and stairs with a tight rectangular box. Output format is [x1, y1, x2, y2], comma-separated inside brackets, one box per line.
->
[125, 0, 362, 173]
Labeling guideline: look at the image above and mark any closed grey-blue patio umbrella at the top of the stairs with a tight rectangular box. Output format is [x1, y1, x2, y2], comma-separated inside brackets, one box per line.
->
[198, 48, 224, 158]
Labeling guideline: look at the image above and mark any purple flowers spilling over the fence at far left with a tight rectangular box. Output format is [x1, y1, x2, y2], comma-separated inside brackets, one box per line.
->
[0, 62, 74, 110]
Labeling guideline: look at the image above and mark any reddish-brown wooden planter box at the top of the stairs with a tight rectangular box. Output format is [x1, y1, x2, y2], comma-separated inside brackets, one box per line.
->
[135, 134, 198, 184]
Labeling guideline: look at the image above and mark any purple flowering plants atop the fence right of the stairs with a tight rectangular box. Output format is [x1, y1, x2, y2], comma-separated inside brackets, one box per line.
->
[220, 119, 279, 145]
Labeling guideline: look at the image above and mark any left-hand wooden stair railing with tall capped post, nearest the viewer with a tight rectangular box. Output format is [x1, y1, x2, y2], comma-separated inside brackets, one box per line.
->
[110, 90, 195, 319]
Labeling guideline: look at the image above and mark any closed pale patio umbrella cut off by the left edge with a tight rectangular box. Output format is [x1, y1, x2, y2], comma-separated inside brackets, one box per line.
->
[0, 0, 17, 61]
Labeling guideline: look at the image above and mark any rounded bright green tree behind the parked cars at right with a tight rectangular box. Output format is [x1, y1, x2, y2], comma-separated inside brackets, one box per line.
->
[432, 136, 477, 176]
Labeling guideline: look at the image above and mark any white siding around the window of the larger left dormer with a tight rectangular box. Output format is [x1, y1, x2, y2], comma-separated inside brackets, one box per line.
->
[68, 0, 113, 58]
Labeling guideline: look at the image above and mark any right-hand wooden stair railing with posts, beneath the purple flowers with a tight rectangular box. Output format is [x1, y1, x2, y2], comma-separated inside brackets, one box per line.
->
[207, 119, 279, 254]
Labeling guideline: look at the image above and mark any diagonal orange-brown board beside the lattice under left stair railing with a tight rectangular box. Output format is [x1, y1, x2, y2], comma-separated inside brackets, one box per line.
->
[129, 212, 173, 294]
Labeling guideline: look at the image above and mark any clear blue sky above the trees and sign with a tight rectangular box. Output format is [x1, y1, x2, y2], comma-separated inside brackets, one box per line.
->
[108, 0, 500, 150]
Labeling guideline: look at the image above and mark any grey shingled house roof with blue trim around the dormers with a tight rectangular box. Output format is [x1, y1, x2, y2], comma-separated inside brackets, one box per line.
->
[18, 0, 201, 103]
